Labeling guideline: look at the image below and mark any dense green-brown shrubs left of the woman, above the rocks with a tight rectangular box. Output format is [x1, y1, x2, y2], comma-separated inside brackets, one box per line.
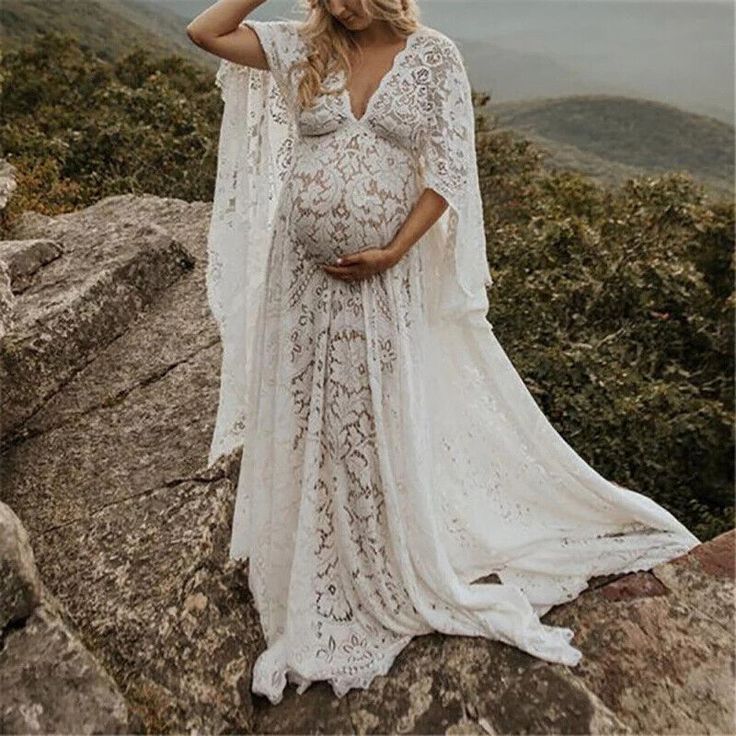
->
[0, 33, 220, 216]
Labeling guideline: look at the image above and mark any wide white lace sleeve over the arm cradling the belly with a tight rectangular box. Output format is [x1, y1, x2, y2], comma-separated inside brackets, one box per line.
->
[420, 37, 493, 328]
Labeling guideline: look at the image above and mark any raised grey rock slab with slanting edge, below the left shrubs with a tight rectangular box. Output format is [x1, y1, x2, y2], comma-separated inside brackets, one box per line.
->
[0, 210, 192, 442]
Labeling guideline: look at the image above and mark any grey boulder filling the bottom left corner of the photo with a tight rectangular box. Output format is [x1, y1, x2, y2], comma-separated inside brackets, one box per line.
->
[0, 502, 130, 734]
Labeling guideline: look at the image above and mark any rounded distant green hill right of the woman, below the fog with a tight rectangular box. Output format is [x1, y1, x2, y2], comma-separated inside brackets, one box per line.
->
[489, 95, 734, 204]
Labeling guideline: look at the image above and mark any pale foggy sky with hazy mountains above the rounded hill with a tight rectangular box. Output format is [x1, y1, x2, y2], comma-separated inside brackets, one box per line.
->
[158, 0, 734, 123]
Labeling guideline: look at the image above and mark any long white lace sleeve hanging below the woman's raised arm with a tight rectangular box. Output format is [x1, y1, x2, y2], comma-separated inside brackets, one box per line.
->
[206, 21, 296, 472]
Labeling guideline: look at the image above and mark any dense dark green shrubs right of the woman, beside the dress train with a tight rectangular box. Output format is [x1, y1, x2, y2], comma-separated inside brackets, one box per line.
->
[478, 95, 734, 538]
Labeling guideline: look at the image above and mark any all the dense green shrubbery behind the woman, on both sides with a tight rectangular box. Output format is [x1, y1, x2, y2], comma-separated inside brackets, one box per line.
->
[0, 35, 734, 539]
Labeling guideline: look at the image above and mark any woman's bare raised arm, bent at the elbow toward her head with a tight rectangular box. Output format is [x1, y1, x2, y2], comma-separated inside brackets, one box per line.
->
[187, 0, 268, 69]
